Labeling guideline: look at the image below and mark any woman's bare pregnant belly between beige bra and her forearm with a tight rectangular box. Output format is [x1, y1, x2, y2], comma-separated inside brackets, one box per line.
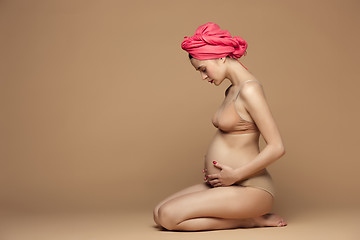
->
[205, 130, 260, 174]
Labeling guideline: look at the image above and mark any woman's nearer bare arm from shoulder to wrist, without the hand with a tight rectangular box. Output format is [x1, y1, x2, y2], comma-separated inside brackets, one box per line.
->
[235, 82, 285, 180]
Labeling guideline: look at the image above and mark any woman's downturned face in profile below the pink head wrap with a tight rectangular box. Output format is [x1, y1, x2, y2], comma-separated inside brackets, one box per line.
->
[190, 58, 226, 86]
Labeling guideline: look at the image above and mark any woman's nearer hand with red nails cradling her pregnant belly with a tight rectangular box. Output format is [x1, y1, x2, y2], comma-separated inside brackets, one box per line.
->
[207, 161, 239, 187]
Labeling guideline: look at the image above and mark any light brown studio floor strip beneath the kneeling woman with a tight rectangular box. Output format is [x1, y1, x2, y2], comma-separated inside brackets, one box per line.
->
[0, 208, 360, 240]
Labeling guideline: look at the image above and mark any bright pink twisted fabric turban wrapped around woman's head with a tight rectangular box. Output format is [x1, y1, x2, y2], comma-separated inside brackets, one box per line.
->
[181, 22, 247, 60]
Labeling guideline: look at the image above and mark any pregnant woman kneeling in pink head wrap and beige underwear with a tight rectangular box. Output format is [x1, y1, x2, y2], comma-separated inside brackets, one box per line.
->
[153, 22, 287, 231]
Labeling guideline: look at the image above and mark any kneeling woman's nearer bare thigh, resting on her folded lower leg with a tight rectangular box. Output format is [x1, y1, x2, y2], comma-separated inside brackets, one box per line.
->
[158, 186, 273, 226]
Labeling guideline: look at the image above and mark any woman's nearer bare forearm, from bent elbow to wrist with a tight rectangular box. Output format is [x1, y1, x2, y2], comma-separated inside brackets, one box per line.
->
[235, 145, 285, 180]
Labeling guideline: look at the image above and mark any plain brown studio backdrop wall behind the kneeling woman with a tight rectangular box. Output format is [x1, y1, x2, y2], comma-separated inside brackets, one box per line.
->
[0, 0, 360, 218]
